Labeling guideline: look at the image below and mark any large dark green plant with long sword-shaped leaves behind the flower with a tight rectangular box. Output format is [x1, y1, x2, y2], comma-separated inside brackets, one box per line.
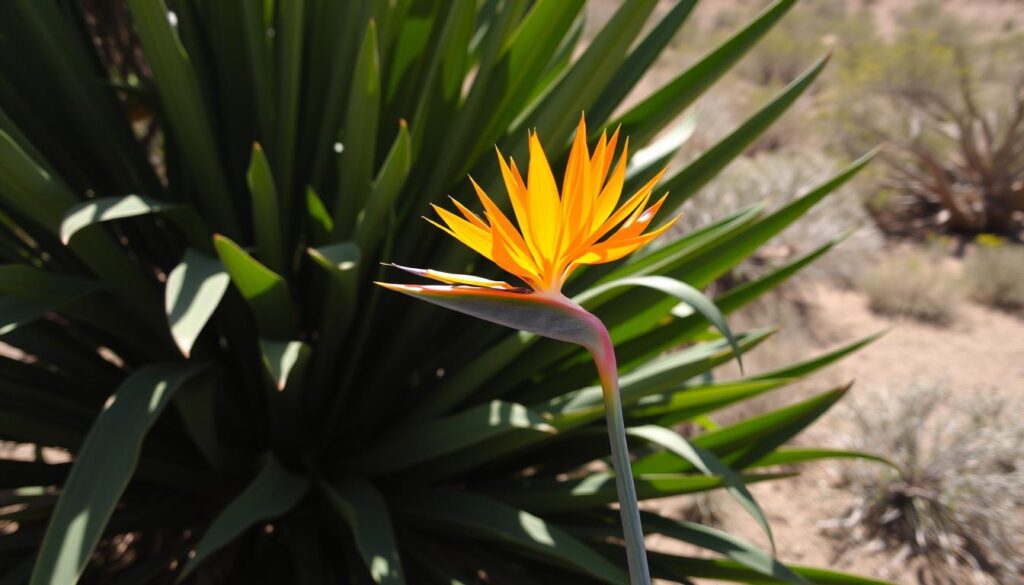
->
[0, 0, 888, 584]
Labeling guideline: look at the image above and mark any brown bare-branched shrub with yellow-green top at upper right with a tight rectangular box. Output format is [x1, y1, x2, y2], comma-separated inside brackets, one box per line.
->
[831, 2, 1024, 238]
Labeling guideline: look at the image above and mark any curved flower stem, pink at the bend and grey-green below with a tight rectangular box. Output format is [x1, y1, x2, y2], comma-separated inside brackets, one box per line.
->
[573, 303, 650, 585]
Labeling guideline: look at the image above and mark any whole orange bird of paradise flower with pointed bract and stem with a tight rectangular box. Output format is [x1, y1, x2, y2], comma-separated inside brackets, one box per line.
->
[377, 117, 732, 583]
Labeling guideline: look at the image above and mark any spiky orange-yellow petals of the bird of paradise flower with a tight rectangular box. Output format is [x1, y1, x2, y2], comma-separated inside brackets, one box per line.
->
[423, 117, 678, 292]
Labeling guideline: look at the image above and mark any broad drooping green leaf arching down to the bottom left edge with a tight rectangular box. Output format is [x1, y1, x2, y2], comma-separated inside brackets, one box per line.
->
[31, 364, 205, 585]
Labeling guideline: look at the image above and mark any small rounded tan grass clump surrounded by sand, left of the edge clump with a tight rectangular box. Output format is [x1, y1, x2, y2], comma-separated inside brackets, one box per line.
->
[860, 252, 961, 325]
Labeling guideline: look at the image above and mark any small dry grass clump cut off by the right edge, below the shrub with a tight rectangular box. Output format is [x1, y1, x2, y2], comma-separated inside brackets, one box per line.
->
[964, 244, 1024, 310]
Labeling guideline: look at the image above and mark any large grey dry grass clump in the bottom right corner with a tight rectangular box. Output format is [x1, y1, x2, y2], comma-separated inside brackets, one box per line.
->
[836, 385, 1024, 583]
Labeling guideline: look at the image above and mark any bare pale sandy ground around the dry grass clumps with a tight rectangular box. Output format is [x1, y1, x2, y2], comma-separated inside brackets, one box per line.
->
[651, 276, 1024, 585]
